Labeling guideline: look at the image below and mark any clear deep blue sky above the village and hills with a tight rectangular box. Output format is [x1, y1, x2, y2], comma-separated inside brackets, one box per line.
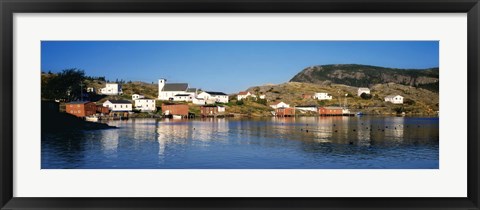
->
[41, 41, 439, 93]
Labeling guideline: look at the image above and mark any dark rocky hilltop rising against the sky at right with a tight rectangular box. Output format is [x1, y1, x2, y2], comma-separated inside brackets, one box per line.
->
[290, 64, 439, 92]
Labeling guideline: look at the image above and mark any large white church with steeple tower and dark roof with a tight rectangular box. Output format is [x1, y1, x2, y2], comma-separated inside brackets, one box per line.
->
[158, 79, 197, 101]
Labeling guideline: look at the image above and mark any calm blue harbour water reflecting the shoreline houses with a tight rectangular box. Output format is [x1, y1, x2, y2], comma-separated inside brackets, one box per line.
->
[42, 117, 439, 169]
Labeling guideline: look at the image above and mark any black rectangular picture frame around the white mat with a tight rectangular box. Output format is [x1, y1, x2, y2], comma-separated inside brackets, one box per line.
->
[0, 0, 480, 209]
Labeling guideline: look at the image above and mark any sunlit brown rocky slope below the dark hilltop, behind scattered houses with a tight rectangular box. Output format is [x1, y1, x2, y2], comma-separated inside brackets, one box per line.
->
[242, 82, 439, 115]
